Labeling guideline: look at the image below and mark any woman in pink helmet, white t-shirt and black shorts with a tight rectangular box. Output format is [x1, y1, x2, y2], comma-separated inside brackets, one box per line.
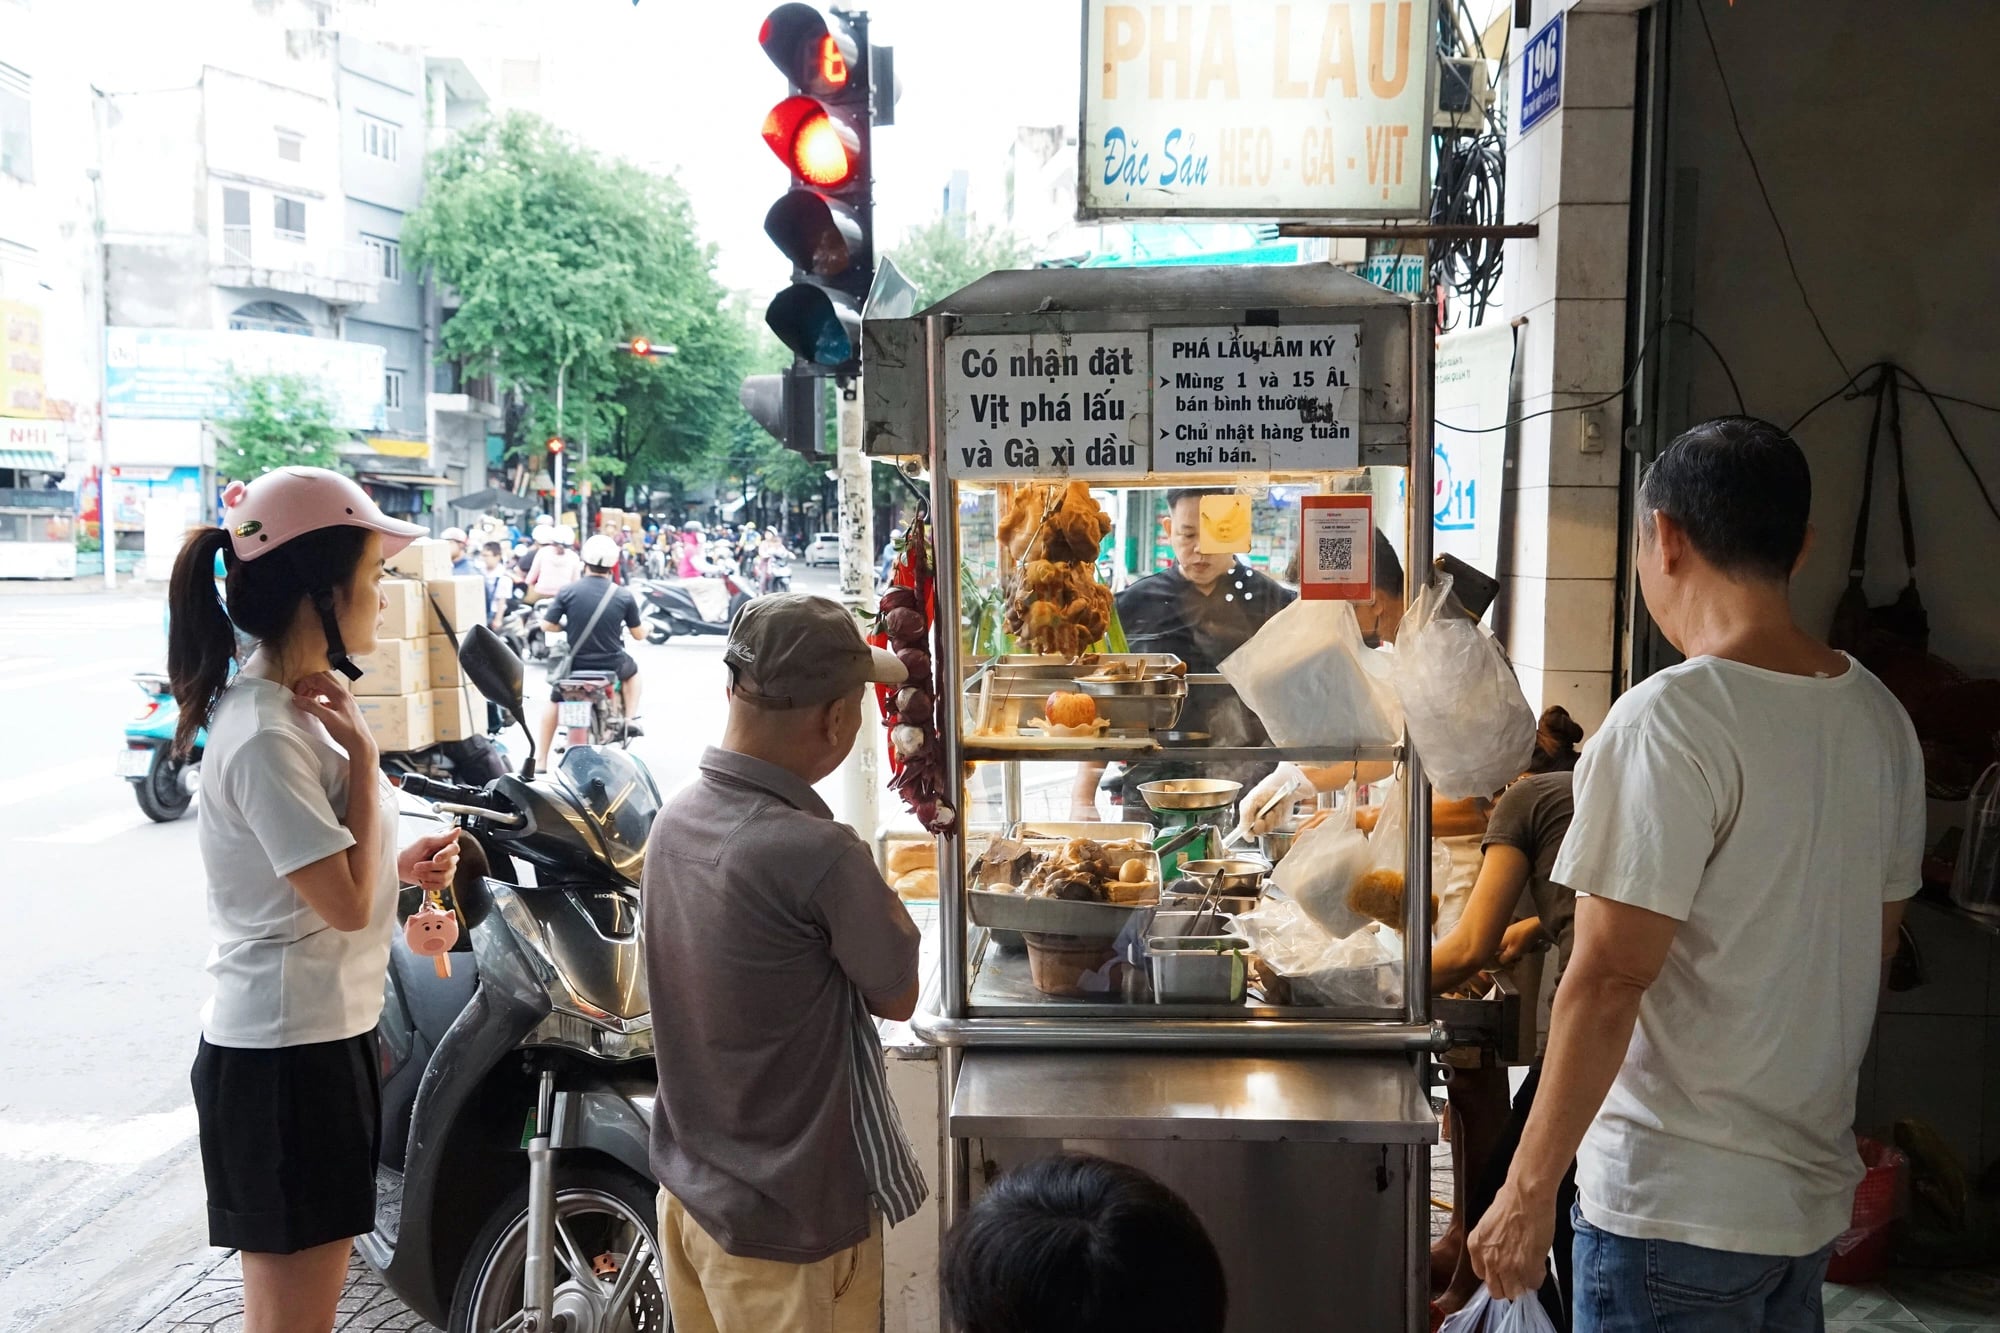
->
[166, 468, 458, 1333]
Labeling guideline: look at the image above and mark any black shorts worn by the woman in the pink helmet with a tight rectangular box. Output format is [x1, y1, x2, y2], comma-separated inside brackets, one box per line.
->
[192, 1031, 382, 1255]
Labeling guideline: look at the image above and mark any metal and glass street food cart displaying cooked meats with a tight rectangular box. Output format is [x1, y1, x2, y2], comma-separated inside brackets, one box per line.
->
[864, 264, 1512, 1331]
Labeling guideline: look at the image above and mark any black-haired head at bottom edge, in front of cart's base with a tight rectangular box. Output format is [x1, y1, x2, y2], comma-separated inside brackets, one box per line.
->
[942, 1155, 1228, 1333]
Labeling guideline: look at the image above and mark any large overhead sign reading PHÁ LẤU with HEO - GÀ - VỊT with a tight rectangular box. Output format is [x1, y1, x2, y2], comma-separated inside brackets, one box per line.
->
[1076, 0, 1436, 218]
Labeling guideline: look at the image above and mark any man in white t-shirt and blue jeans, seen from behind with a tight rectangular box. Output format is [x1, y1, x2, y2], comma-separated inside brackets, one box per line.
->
[1470, 416, 1924, 1333]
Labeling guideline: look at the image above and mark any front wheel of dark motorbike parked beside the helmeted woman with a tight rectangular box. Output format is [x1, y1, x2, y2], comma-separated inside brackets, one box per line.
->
[452, 1167, 672, 1333]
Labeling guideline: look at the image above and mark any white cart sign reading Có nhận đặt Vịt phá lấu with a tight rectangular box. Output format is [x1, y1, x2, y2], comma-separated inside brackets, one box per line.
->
[944, 332, 1152, 476]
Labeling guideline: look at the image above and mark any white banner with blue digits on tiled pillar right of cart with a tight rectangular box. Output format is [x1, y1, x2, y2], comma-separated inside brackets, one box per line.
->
[1430, 324, 1504, 572]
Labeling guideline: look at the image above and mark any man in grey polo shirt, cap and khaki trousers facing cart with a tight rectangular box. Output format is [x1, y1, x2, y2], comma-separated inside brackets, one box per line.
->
[644, 594, 924, 1333]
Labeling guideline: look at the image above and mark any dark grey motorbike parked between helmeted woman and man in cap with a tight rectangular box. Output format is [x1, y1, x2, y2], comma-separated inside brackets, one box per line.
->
[356, 626, 670, 1333]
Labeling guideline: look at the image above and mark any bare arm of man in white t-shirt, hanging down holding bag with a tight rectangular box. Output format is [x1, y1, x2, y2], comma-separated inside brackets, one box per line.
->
[1470, 897, 1680, 1299]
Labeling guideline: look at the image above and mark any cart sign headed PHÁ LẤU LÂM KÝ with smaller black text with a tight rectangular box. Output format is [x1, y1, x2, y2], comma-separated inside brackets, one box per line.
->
[1152, 324, 1362, 472]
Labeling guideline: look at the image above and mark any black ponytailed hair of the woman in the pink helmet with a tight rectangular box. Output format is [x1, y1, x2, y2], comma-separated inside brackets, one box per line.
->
[166, 526, 368, 755]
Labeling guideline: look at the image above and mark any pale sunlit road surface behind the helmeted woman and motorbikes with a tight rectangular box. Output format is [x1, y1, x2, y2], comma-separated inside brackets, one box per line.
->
[0, 570, 834, 1333]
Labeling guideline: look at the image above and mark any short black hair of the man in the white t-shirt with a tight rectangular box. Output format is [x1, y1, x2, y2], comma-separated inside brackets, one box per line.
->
[1638, 416, 1812, 582]
